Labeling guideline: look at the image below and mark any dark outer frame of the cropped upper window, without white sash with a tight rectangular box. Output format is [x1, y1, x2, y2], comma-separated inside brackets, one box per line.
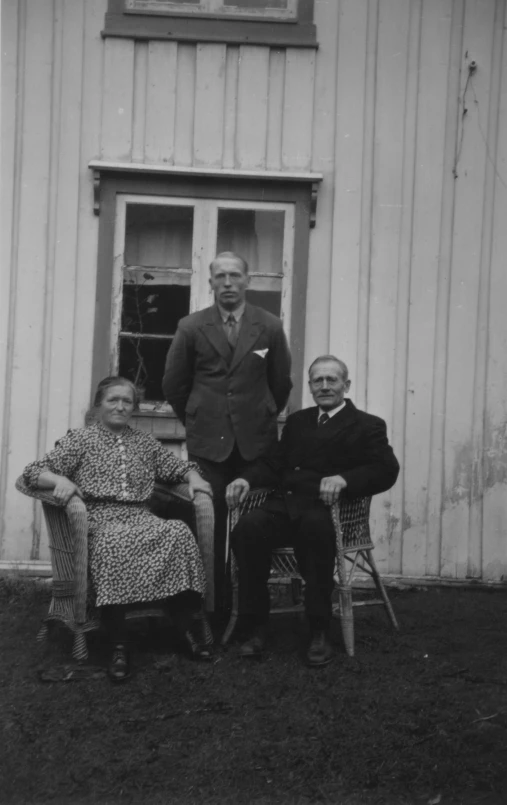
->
[102, 0, 318, 48]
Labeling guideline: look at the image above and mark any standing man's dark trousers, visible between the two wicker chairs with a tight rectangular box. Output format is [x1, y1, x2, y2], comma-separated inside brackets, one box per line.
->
[188, 445, 253, 614]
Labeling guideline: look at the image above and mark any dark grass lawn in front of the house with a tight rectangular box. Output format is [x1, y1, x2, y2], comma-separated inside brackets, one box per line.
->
[0, 580, 507, 805]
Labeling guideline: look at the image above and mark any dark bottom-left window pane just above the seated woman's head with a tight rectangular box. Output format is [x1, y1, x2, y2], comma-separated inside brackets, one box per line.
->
[119, 336, 171, 400]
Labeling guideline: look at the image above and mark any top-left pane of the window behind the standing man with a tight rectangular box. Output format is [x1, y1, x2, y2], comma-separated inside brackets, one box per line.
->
[125, 204, 194, 269]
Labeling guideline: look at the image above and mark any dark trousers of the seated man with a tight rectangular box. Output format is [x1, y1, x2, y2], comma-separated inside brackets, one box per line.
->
[231, 497, 336, 629]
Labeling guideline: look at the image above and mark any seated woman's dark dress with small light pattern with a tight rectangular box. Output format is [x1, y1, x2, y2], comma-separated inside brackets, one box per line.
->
[23, 424, 205, 606]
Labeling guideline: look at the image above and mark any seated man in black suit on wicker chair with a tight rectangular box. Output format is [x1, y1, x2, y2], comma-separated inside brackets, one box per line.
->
[226, 355, 399, 666]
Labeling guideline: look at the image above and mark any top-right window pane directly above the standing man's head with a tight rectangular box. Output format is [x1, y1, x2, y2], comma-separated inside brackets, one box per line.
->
[217, 208, 285, 274]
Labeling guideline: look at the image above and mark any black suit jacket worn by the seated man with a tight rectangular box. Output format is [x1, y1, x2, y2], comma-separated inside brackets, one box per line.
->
[242, 400, 400, 516]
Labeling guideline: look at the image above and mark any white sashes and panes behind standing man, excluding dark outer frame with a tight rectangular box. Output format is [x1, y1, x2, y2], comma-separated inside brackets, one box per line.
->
[110, 194, 294, 411]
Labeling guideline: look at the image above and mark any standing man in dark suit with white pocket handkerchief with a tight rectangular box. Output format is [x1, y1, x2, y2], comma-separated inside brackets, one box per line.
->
[162, 252, 292, 610]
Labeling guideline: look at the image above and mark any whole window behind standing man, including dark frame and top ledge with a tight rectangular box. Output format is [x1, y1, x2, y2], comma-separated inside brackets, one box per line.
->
[92, 171, 315, 434]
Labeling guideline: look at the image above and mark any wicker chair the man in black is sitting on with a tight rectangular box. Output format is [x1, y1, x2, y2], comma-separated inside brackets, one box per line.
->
[222, 489, 398, 657]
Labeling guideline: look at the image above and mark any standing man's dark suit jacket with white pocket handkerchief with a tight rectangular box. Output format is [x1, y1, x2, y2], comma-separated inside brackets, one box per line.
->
[162, 304, 292, 462]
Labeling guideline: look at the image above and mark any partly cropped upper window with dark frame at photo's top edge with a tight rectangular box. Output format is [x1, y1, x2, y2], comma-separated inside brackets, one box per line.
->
[102, 0, 317, 47]
